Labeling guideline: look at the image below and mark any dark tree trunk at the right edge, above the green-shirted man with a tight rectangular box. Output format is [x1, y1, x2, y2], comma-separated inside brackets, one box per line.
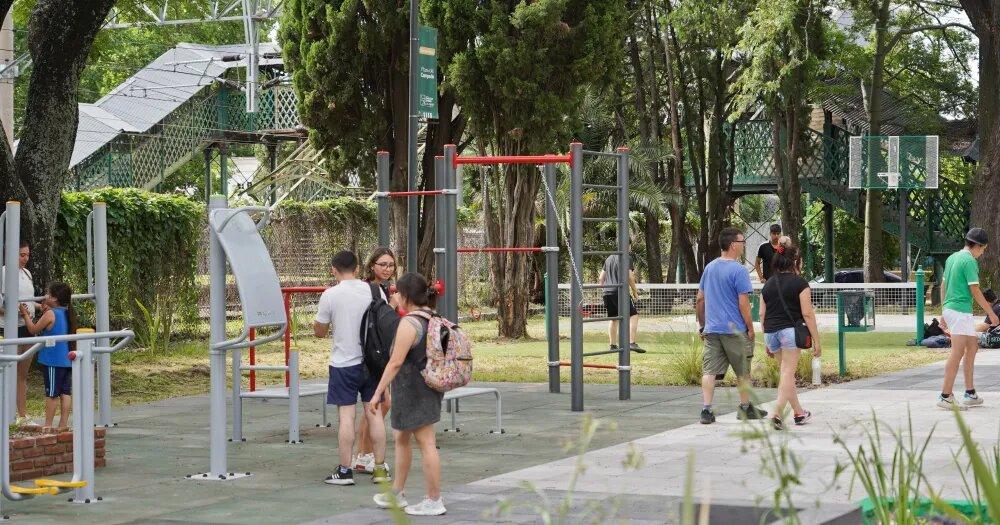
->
[962, 0, 1000, 285]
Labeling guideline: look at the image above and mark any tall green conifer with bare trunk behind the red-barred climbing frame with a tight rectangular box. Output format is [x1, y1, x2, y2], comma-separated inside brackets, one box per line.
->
[438, 0, 624, 338]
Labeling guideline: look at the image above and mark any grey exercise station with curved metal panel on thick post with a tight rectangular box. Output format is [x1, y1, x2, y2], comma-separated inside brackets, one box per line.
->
[187, 195, 288, 480]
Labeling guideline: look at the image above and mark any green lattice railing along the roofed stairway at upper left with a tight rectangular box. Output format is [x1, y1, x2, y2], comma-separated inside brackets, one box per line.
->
[70, 86, 299, 191]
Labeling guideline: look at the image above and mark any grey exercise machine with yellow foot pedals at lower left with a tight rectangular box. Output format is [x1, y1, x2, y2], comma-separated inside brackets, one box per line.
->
[0, 328, 135, 519]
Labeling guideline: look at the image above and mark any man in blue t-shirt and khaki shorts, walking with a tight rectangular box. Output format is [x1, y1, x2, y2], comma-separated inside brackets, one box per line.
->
[695, 228, 767, 425]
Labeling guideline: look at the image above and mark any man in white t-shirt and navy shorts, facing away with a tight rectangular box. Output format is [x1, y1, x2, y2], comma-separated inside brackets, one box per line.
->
[313, 250, 392, 485]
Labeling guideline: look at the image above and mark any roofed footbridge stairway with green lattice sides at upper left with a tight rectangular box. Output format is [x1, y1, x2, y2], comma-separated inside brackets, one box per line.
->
[67, 44, 303, 190]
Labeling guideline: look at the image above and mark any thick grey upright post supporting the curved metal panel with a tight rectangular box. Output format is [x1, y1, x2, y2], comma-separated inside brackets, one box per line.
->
[208, 195, 229, 479]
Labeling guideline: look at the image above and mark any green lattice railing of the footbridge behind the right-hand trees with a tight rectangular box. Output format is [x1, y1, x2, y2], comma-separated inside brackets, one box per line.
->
[687, 120, 972, 255]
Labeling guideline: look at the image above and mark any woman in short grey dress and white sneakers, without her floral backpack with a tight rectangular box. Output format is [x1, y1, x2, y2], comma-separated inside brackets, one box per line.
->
[369, 273, 445, 516]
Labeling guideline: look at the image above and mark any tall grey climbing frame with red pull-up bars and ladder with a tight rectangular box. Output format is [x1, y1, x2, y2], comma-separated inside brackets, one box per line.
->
[374, 142, 632, 411]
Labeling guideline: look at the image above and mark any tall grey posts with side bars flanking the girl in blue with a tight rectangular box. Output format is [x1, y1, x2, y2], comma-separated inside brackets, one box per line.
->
[3, 201, 114, 427]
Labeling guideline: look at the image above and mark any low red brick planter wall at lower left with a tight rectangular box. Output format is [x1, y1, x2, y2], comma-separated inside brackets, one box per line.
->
[10, 425, 105, 481]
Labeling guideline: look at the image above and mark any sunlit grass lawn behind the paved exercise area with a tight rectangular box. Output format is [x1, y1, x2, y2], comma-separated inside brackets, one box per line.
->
[17, 316, 946, 417]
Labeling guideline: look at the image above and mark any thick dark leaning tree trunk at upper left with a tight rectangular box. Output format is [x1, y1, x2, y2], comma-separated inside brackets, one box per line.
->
[2, 0, 114, 283]
